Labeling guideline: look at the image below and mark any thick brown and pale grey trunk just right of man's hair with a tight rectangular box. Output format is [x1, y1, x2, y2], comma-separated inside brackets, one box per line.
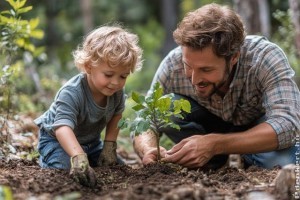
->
[233, 0, 271, 37]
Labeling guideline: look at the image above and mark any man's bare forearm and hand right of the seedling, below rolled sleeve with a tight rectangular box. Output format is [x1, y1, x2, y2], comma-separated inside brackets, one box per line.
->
[163, 123, 278, 168]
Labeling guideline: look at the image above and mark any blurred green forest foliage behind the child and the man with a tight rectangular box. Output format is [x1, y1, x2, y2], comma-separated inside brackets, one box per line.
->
[0, 0, 300, 148]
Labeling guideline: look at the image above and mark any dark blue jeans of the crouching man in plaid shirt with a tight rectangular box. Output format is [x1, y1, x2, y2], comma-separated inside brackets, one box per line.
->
[160, 94, 299, 169]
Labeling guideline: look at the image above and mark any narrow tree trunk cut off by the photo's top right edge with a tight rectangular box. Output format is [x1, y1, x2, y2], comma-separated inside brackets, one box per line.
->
[289, 0, 300, 57]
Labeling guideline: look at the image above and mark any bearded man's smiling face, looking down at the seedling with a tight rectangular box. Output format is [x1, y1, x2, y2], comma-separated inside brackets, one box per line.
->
[182, 46, 236, 98]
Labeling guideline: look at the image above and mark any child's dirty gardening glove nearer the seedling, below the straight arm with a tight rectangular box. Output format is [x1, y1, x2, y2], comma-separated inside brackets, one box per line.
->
[98, 140, 118, 166]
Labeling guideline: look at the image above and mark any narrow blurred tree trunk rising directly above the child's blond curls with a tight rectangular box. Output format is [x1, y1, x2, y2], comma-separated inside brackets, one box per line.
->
[80, 0, 94, 35]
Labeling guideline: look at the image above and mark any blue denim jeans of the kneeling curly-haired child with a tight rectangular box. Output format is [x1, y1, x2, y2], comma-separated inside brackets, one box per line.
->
[38, 128, 123, 169]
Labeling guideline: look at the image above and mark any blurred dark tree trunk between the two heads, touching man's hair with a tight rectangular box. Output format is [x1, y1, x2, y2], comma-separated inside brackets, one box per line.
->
[161, 0, 178, 57]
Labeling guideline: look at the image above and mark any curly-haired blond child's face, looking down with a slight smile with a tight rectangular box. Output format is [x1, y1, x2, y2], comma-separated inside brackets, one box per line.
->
[85, 63, 130, 99]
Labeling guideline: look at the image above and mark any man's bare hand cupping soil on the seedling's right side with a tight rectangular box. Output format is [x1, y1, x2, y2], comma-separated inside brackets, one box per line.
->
[162, 135, 215, 168]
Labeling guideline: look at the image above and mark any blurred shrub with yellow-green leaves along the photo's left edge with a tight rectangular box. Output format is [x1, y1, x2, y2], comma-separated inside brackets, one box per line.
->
[0, 0, 44, 138]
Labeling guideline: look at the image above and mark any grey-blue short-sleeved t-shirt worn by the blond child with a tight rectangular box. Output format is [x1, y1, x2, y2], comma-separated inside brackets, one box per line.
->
[34, 73, 125, 144]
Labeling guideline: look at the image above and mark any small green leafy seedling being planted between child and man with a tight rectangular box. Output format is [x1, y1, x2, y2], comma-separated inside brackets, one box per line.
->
[118, 83, 191, 161]
